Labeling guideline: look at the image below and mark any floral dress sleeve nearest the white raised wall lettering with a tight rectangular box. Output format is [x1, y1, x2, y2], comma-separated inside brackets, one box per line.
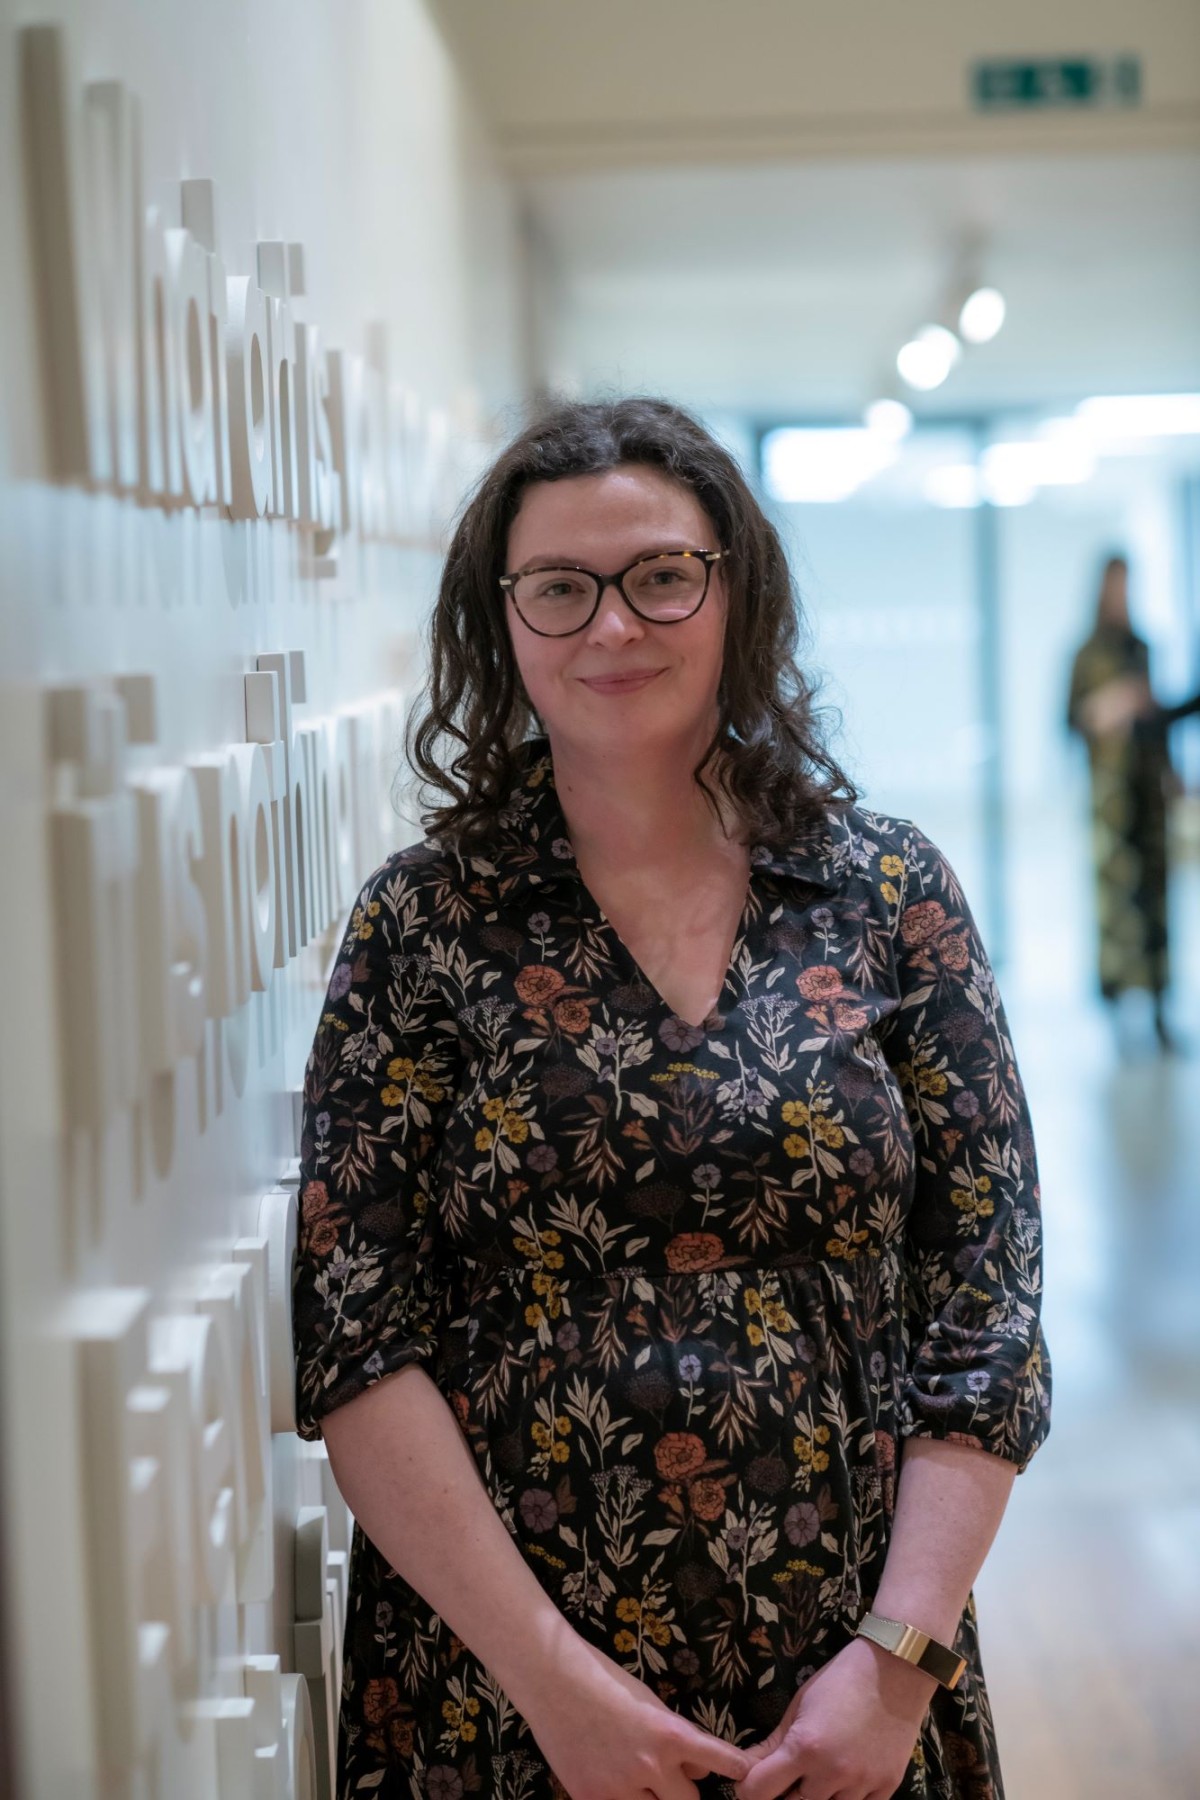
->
[291, 851, 459, 1438]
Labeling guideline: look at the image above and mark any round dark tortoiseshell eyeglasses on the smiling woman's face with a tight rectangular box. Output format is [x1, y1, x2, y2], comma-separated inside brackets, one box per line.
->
[500, 551, 725, 637]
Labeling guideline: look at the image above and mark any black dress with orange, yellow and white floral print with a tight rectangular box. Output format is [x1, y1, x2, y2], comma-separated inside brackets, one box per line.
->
[293, 738, 1051, 1800]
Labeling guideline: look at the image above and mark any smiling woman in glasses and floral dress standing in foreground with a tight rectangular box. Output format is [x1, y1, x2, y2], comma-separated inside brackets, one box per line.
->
[295, 400, 1049, 1800]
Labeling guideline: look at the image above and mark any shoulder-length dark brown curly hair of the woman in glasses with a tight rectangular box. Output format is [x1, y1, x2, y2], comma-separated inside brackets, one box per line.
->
[405, 396, 858, 851]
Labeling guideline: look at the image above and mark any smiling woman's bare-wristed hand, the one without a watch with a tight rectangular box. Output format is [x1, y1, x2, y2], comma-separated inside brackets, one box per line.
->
[524, 1634, 750, 1800]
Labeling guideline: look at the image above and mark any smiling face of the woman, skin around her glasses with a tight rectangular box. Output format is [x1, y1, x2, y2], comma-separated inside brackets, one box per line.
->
[506, 464, 727, 752]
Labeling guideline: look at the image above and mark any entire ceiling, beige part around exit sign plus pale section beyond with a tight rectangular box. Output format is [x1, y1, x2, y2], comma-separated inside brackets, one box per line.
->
[428, 0, 1200, 421]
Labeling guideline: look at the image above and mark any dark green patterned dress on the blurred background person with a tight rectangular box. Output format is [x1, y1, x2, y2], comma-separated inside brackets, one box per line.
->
[1067, 625, 1169, 999]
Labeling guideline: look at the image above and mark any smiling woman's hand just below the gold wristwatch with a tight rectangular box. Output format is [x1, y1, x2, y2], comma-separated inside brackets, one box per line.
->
[738, 1638, 937, 1800]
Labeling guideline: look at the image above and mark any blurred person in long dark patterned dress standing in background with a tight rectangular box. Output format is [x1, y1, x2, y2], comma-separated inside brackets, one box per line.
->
[1067, 556, 1171, 1048]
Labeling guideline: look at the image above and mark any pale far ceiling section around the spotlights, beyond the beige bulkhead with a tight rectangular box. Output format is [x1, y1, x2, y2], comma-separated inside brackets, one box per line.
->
[524, 149, 1200, 421]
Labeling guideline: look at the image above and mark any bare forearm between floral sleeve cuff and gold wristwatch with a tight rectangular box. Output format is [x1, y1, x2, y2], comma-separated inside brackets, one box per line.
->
[867, 1438, 1016, 1643]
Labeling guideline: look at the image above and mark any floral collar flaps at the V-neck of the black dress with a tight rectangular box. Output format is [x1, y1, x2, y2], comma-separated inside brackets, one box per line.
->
[489, 736, 844, 895]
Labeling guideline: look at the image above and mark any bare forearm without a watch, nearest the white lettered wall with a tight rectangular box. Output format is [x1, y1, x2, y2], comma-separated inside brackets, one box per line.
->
[322, 1364, 574, 1714]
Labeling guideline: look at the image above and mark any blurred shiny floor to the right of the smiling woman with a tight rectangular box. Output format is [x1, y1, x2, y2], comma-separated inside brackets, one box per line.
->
[975, 983, 1200, 1800]
